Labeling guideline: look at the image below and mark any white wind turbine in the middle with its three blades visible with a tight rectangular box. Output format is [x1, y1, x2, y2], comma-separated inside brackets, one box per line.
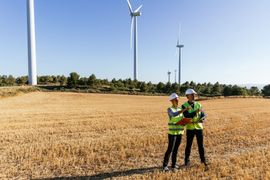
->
[127, 0, 142, 80]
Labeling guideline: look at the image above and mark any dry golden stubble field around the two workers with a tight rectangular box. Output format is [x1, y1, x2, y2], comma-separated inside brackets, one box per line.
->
[0, 92, 270, 179]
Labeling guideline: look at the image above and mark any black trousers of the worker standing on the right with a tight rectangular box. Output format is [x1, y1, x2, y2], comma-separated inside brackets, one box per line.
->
[185, 130, 205, 163]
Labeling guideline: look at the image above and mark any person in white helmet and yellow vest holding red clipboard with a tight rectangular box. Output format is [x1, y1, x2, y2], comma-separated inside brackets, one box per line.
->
[163, 93, 191, 171]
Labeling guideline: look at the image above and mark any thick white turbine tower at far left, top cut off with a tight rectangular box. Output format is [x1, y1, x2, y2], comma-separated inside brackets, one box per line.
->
[27, 0, 37, 86]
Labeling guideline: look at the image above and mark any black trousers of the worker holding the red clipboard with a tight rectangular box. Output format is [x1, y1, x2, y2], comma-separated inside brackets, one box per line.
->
[163, 134, 182, 167]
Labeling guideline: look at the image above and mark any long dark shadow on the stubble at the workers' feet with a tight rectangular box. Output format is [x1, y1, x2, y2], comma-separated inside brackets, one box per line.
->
[40, 167, 161, 180]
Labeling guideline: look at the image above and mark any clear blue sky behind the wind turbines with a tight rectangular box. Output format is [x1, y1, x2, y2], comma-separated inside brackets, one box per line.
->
[0, 0, 270, 84]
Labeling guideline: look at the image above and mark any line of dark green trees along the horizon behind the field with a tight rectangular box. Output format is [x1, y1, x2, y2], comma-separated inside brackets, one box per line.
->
[0, 72, 270, 97]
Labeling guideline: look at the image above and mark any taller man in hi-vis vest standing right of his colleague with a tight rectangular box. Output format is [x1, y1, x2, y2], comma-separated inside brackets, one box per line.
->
[182, 89, 207, 167]
